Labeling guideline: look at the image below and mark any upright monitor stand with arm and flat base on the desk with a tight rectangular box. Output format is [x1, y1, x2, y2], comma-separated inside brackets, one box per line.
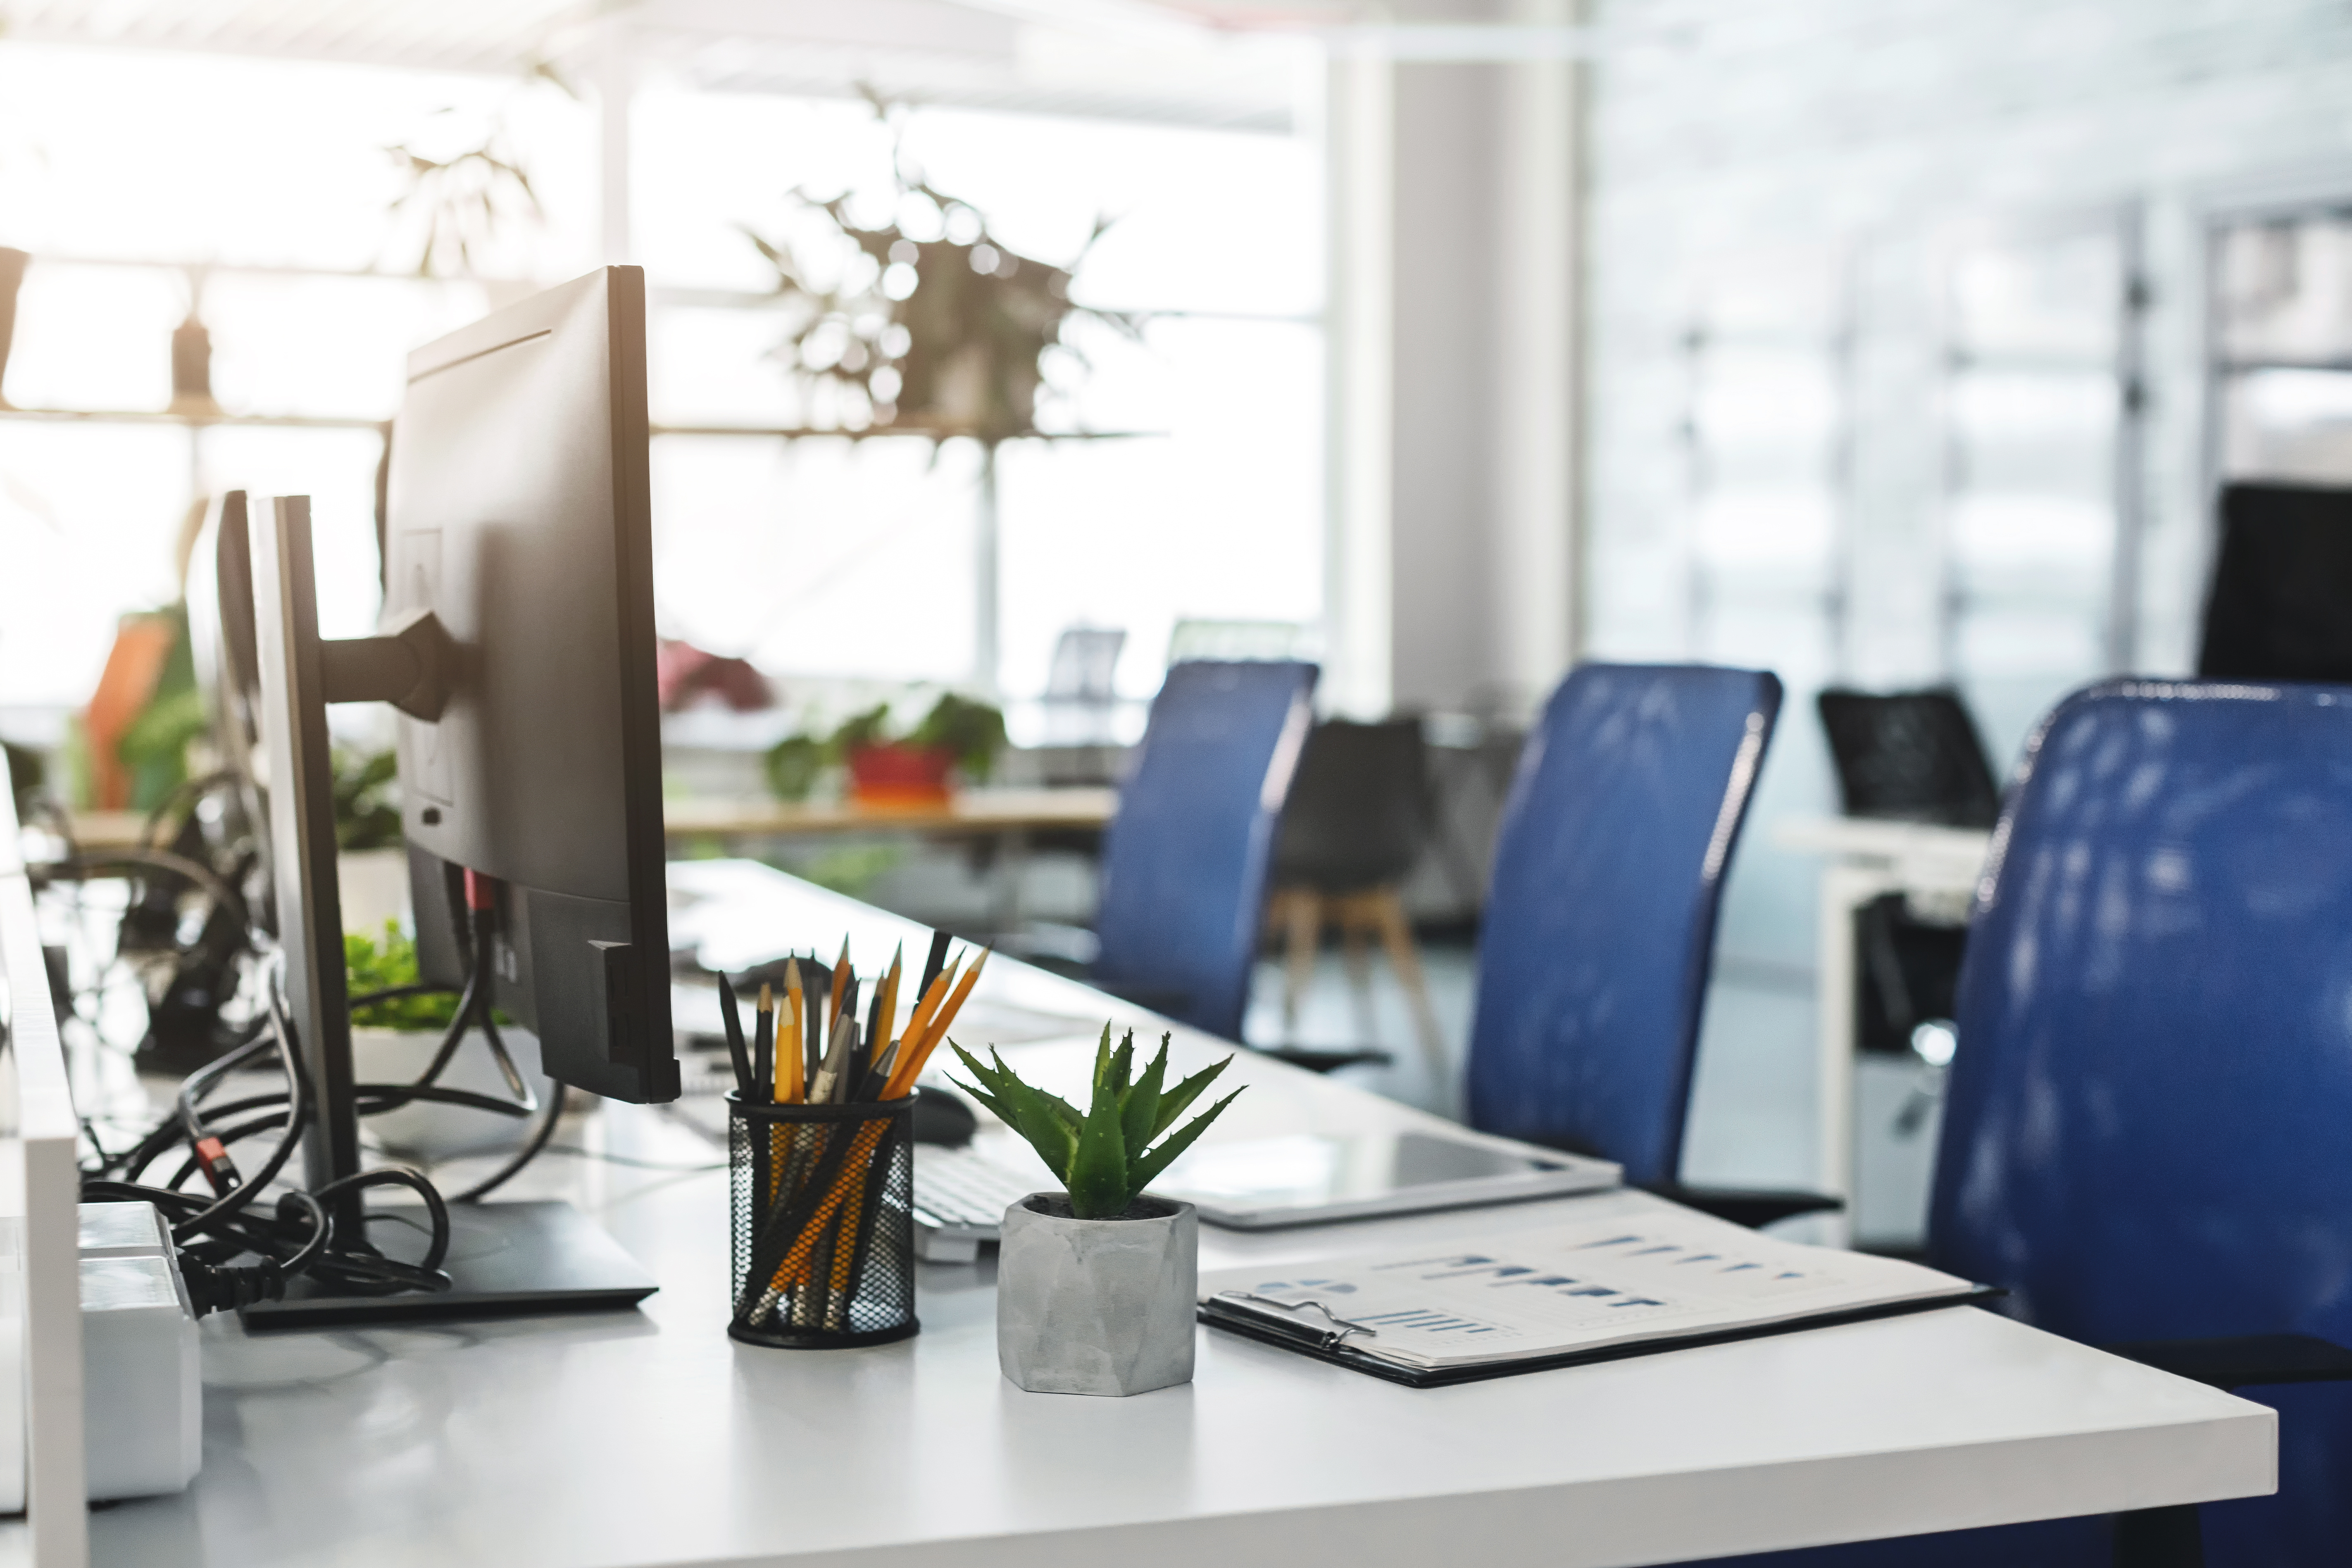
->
[242, 496, 656, 1328]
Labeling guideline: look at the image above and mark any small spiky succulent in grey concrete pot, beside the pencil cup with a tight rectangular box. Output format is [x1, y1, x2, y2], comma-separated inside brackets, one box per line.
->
[955, 1023, 1242, 1394]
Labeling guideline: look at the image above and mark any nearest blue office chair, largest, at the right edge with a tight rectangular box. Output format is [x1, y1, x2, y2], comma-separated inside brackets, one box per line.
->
[1674, 682, 2352, 1568]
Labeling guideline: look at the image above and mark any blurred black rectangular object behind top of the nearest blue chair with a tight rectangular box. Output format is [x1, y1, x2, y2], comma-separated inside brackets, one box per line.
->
[2197, 484, 2352, 682]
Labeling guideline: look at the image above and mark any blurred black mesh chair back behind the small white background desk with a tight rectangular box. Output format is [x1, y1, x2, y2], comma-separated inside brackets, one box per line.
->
[1818, 686, 2002, 828]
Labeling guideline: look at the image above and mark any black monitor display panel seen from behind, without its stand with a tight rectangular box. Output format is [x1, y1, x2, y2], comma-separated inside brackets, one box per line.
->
[383, 268, 677, 1102]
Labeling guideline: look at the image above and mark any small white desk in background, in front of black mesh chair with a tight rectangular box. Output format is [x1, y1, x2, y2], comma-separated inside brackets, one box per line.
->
[1774, 816, 1992, 1234]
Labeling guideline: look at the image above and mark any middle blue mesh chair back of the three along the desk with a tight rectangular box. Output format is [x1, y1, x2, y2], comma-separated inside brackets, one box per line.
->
[1470, 665, 1781, 1183]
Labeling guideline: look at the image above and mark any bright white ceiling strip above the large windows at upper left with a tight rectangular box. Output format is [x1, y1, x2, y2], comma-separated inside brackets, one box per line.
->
[0, 0, 1326, 129]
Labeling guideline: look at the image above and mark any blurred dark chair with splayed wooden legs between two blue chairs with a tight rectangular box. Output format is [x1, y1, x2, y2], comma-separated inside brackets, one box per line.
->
[1265, 719, 1444, 1072]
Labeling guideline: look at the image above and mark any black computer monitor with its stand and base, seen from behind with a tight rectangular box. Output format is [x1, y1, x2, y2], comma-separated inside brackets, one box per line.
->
[245, 268, 680, 1323]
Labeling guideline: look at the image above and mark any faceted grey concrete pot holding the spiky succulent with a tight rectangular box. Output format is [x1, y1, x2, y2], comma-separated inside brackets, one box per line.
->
[997, 1192, 1200, 1394]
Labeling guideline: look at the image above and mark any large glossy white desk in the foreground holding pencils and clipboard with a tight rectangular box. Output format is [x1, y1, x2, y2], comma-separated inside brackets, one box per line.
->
[45, 863, 2277, 1568]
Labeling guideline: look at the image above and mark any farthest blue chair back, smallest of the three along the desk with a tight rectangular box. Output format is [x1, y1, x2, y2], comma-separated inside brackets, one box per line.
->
[1094, 661, 1315, 1039]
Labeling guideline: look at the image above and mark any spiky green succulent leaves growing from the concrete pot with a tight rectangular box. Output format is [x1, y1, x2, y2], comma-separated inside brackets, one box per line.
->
[948, 1023, 1242, 1220]
